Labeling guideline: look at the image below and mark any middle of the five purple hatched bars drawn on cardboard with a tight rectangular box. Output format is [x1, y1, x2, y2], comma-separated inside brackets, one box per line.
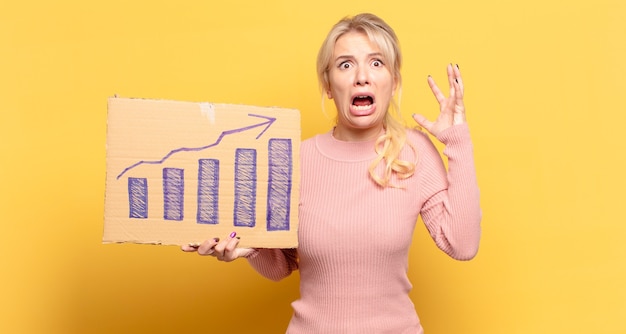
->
[197, 159, 220, 224]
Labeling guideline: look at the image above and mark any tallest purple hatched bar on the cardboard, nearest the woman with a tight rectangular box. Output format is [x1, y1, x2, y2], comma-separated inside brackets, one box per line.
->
[267, 138, 292, 231]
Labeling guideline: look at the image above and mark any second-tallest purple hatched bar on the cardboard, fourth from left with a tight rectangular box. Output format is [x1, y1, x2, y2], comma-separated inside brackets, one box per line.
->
[233, 148, 256, 227]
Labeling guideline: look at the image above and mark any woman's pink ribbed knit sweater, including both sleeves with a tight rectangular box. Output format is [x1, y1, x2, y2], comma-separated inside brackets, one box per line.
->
[248, 124, 481, 334]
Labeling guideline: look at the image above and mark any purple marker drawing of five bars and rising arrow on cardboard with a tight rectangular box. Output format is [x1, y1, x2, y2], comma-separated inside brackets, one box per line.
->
[122, 114, 293, 231]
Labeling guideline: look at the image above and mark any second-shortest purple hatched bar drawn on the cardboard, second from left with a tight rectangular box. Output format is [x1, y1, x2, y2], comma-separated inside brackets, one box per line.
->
[163, 168, 185, 220]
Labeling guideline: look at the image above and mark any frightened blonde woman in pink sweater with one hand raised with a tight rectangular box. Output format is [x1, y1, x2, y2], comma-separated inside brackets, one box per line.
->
[182, 14, 481, 334]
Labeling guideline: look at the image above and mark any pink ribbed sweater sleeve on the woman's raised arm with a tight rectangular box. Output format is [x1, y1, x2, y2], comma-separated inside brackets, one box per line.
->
[420, 123, 482, 260]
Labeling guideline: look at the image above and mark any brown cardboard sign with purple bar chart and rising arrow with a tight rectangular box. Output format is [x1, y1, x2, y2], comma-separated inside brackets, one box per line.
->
[103, 99, 300, 247]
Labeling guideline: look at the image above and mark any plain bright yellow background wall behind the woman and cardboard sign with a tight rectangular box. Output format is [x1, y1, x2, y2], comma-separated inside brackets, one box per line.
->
[0, 0, 626, 334]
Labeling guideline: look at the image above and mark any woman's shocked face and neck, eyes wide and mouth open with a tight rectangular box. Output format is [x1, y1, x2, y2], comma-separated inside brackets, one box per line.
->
[327, 31, 396, 140]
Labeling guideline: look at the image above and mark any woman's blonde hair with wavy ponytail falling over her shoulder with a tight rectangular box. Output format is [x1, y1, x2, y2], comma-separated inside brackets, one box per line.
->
[317, 13, 415, 187]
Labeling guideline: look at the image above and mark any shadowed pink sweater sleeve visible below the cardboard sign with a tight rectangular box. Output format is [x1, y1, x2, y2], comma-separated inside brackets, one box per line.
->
[246, 248, 298, 281]
